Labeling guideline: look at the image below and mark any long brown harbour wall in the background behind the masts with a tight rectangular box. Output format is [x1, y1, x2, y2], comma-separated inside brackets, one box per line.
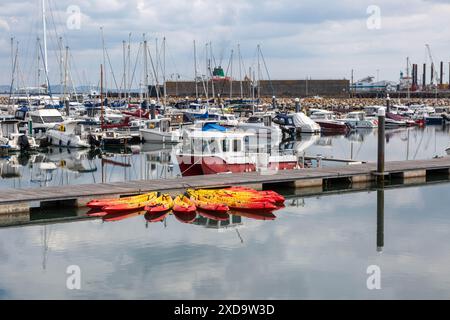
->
[166, 80, 350, 98]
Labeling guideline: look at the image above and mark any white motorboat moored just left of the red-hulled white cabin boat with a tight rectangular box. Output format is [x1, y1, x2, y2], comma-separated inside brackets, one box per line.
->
[139, 118, 181, 144]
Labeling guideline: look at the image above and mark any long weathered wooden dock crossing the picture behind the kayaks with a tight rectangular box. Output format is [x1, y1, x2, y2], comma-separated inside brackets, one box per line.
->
[0, 157, 450, 214]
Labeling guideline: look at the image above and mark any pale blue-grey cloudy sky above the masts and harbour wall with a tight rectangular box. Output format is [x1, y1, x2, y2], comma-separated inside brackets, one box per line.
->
[0, 0, 450, 85]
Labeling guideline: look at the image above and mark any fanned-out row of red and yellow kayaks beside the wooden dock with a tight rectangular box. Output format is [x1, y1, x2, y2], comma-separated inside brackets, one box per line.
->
[87, 187, 285, 221]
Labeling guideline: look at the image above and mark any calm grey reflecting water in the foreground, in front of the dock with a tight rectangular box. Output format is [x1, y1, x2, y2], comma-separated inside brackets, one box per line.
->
[0, 184, 450, 299]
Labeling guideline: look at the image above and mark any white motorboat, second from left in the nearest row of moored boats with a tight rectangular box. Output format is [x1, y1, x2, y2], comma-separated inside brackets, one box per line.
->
[46, 120, 90, 148]
